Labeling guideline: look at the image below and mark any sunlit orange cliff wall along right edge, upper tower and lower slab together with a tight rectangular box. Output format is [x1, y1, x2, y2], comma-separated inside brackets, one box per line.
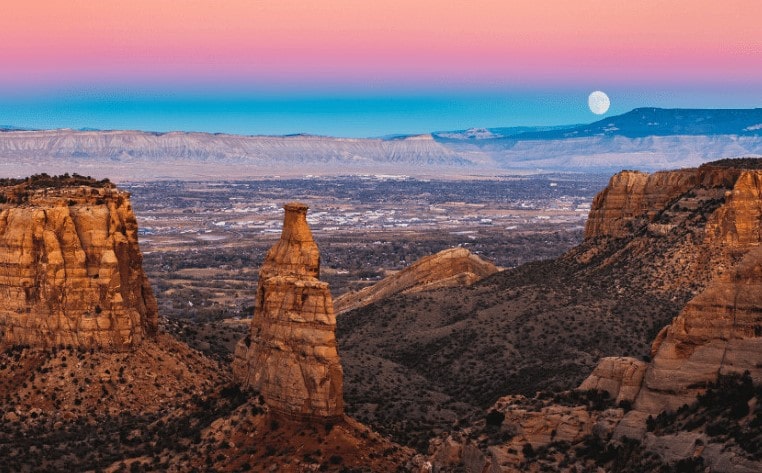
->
[604, 170, 762, 436]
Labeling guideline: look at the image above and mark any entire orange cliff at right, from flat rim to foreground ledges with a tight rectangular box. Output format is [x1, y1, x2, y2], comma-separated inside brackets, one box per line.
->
[430, 159, 762, 472]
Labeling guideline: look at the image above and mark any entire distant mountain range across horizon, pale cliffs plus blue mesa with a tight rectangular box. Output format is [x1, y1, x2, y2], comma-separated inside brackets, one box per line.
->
[0, 108, 762, 179]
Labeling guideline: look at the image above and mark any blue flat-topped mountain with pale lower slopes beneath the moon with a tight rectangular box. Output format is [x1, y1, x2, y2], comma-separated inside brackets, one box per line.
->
[433, 108, 762, 172]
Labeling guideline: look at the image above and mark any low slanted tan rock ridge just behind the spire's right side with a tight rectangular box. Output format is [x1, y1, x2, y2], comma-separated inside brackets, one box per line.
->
[334, 248, 498, 314]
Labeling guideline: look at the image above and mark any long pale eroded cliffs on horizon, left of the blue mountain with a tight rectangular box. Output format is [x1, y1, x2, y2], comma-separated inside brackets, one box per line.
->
[0, 129, 476, 180]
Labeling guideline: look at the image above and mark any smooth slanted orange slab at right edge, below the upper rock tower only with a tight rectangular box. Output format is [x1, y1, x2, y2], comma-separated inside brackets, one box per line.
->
[618, 247, 762, 437]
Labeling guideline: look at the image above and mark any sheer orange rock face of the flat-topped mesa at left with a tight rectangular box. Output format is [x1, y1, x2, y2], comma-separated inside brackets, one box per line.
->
[0, 184, 158, 350]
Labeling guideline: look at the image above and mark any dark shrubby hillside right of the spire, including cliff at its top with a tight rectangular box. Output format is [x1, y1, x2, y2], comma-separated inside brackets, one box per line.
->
[338, 159, 756, 448]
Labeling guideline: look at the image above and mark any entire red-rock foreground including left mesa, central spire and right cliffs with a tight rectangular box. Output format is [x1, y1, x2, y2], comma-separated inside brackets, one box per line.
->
[0, 159, 762, 472]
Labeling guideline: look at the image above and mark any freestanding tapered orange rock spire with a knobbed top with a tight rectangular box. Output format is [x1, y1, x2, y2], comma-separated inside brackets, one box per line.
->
[233, 203, 344, 419]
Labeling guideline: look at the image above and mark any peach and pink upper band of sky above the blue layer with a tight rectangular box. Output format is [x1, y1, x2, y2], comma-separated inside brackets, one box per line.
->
[0, 0, 762, 86]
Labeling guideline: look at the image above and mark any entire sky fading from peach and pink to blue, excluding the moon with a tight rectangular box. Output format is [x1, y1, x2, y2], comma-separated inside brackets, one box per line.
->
[0, 0, 762, 137]
